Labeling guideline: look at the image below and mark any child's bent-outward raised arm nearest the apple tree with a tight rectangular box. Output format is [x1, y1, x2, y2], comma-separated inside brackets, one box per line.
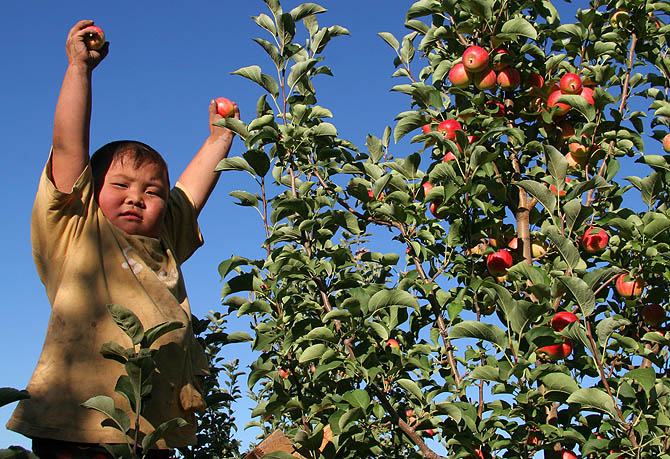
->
[179, 101, 240, 213]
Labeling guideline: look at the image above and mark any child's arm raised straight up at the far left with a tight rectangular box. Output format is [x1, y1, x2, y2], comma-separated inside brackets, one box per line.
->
[51, 20, 109, 193]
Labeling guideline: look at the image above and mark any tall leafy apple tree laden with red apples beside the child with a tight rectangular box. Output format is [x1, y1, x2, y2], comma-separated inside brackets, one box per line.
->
[214, 0, 670, 458]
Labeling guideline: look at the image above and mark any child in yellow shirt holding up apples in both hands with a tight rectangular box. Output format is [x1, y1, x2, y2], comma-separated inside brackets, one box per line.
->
[7, 20, 239, 459]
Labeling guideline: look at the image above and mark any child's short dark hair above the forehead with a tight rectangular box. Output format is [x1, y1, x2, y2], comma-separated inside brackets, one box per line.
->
[91, 140, 170, 187]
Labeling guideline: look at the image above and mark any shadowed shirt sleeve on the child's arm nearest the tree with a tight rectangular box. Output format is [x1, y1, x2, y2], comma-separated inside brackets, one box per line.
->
[162, 182, 204, 264]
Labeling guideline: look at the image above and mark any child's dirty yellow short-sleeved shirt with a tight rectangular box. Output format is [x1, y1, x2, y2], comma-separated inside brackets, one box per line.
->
[7, 158, 207, 447]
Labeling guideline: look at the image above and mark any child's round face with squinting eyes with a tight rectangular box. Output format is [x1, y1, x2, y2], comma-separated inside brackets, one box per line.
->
[98, 158, 168, 237]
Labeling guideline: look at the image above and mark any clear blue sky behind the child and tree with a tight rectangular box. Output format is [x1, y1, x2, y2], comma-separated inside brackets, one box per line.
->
[0, 0, 652, 456]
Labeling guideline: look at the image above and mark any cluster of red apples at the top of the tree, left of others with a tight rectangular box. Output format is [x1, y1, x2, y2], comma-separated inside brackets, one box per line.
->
[448, 46, 521, 91]
